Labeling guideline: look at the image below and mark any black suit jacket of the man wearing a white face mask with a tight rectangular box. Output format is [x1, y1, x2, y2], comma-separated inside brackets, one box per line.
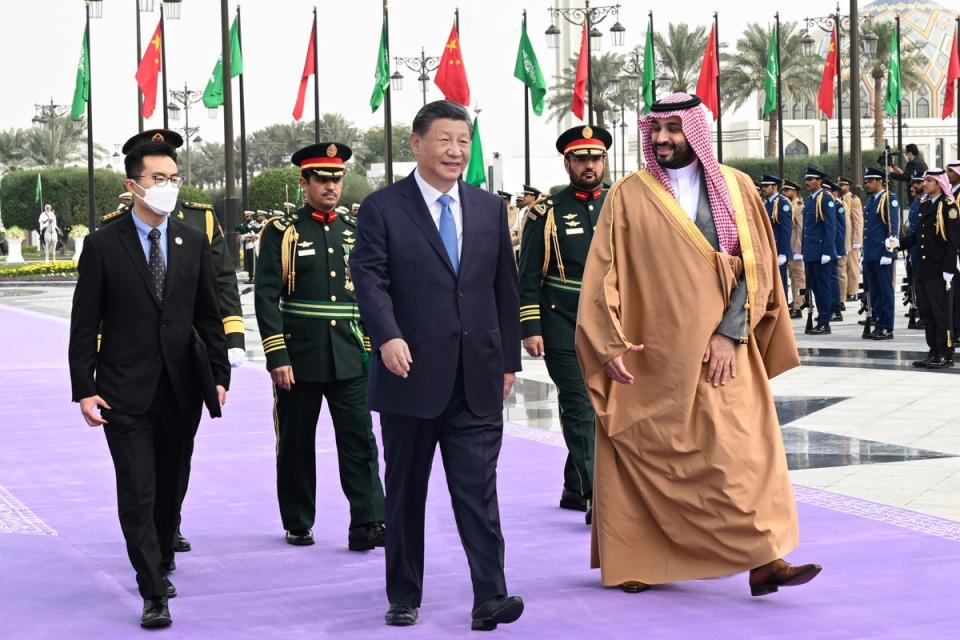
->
[69, 216, 230, 413]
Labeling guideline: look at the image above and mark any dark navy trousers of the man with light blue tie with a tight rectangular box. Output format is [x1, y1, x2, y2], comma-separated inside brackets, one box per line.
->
[380, 370, 507, 607]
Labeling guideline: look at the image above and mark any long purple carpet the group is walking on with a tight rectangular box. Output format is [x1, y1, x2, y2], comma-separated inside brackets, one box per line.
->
[0, 306, 960, 639]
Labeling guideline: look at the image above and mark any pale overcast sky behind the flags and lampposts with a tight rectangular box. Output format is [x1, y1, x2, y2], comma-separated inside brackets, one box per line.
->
[0, 0, 865, 169]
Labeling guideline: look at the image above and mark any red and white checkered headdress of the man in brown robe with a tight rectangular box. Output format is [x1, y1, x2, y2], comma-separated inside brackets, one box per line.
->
[637, 93, 740, 256]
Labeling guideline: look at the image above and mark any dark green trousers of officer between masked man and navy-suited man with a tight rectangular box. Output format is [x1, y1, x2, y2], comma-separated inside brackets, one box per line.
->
[274, 375, 383, 531]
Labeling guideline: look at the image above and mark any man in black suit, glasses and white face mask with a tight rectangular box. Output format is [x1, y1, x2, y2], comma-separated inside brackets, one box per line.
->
[69, 131, 230, 627]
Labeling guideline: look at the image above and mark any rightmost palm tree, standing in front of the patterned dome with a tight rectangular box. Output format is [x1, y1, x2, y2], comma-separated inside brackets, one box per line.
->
[860, 20, 927, 149]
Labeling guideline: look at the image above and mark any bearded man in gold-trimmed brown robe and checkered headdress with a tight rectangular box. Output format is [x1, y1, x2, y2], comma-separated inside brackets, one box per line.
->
[576, 93, 821, 596]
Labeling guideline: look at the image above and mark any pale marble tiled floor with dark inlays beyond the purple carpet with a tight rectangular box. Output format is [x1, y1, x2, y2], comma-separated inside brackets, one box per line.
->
[0, 285, 960, 521]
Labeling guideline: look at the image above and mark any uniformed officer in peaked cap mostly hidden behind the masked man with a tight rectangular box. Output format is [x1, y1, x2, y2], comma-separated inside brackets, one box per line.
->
[100, 129, 247, 560]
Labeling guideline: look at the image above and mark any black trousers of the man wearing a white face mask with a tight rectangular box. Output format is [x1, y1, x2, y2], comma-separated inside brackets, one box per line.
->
[101, 370, 202, 598]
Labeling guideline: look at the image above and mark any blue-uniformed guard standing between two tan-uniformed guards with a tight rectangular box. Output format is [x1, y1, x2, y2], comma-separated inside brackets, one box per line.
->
[801, 167, 837, 335]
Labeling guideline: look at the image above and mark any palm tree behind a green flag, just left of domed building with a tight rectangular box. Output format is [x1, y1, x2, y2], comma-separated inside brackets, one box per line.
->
[720, 22, 820, 156]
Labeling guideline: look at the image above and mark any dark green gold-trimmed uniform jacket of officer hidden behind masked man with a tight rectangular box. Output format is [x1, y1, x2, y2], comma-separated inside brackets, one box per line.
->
[100, 202, 245, 349]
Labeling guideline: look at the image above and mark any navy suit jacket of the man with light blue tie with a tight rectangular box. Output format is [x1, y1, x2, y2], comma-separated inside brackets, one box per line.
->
[350, 174, 520, 418]
